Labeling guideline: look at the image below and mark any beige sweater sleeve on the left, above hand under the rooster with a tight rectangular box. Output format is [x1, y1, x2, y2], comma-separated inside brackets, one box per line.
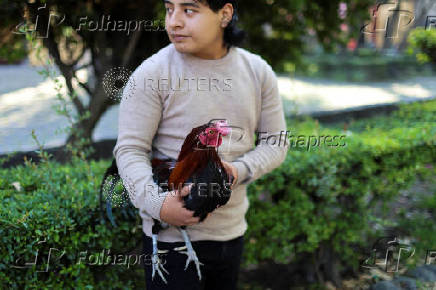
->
[113, 59, 166, 220]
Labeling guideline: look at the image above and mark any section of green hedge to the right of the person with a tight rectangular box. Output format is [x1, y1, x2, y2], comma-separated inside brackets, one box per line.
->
[245, 101, 436, 278]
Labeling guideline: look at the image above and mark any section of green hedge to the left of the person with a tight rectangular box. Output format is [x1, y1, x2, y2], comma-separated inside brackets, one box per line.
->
[0, 157, 142, 289]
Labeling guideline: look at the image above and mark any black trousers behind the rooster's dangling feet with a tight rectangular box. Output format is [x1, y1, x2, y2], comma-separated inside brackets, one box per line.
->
[143, 234, 244, 290]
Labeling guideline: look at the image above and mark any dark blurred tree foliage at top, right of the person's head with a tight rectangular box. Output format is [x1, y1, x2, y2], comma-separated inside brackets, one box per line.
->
[238, 0, 372, 71]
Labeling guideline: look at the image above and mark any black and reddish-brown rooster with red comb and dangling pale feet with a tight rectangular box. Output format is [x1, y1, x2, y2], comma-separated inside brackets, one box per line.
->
[151, 119, 234, 283]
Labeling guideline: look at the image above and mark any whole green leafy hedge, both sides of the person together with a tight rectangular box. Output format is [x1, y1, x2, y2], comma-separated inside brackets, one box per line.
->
[0, 101, 436, 289]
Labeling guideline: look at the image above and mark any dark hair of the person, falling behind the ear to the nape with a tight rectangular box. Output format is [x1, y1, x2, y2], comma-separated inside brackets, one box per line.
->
[197, 0, 246, 48]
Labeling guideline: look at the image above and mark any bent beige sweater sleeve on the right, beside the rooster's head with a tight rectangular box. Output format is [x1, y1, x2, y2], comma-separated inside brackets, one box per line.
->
[232, 60, 289, 185]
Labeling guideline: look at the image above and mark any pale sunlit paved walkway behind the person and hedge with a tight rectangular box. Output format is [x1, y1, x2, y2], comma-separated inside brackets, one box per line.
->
[0, 59, 436, 153]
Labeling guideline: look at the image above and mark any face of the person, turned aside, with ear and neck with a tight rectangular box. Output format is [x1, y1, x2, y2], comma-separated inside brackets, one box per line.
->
[164, 0, 233, 58]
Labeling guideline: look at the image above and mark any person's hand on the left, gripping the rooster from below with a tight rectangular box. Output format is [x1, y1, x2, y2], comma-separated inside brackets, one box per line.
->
[160, 184, 209, 226]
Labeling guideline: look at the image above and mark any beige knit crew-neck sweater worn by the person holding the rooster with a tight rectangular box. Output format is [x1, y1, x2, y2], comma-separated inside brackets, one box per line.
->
[113, 44, 289, 242]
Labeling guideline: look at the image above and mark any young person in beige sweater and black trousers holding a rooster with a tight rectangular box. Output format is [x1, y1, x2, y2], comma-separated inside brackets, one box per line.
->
[113, 0, 288, 290]
